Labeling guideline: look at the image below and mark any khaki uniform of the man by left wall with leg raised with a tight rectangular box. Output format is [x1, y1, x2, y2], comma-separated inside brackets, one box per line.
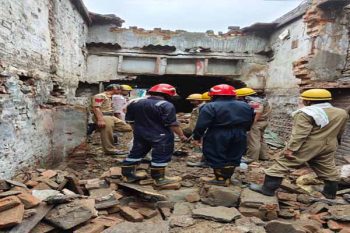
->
[91, 92, 132, 153]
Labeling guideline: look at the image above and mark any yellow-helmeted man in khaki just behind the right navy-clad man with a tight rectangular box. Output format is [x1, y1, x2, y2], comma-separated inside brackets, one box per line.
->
[236, 87, 272, 163]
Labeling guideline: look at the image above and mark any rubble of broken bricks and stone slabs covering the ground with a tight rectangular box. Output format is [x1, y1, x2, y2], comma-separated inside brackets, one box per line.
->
[0, 134, 350, 233]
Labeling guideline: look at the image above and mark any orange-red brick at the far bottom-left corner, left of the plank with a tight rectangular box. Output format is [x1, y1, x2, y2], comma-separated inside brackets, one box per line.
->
[0, 203, 24, 229]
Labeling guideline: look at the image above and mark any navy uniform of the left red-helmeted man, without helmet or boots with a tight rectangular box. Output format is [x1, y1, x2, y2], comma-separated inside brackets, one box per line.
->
[124, 96, 178, 167]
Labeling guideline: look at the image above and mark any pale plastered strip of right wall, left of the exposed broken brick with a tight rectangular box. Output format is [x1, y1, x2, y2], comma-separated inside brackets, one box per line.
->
[265, 18, 311, 138]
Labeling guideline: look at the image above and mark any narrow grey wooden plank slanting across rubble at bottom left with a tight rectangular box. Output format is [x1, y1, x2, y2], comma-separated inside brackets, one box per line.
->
[5, 203, 53, 233]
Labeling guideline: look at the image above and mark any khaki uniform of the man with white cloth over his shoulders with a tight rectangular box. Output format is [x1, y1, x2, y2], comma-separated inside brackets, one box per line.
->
[265, 107, 348, 181]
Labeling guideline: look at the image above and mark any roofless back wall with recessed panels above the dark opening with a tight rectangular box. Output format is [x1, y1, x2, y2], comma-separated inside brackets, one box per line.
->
[86, 25, 268, 89]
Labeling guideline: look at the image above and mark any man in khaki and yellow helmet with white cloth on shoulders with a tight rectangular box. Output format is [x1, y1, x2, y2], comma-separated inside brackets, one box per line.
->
[250, 89, 349, 199]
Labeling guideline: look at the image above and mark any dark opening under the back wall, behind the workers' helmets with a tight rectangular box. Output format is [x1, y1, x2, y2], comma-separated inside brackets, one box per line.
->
[106, 75, 246, 112]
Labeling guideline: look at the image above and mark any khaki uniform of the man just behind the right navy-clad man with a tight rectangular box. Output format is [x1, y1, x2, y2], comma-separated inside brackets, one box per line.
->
[247, 98, 271, 161]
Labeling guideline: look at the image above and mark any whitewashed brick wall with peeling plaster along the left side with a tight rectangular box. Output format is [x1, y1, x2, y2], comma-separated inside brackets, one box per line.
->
[0, 0, 87, 178]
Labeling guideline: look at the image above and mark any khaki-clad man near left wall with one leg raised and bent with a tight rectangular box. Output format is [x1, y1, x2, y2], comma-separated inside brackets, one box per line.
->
[92, 84, 132, 155]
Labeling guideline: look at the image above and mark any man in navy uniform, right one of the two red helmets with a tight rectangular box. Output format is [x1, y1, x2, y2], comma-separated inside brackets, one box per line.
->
[193, 84, 254, 186]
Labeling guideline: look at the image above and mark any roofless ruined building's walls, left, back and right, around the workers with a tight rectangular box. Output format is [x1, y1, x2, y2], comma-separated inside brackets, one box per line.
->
[0, 0, 350, 178]
